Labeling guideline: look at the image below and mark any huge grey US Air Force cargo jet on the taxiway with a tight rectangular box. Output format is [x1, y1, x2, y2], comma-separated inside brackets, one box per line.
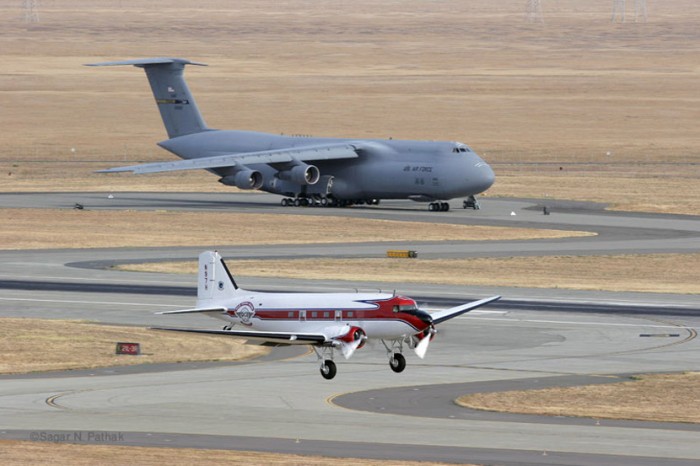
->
[88, 58, 494, 211]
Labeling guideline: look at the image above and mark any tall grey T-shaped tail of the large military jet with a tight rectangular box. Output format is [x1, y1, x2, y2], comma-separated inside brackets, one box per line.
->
[86, 58, 209, 138]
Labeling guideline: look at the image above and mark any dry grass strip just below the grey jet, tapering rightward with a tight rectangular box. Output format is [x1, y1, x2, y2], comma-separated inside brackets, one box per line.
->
[0, 209, 594, 249]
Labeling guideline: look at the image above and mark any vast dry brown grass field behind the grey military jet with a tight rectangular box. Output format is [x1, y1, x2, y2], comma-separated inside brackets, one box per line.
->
[0, 0, 700, 213]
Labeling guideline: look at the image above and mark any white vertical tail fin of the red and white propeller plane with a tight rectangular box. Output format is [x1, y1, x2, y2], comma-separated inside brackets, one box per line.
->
[197, 251, 239, 308]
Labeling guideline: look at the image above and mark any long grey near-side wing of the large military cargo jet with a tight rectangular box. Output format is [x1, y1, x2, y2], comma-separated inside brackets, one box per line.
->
[97, 143, 358, 174]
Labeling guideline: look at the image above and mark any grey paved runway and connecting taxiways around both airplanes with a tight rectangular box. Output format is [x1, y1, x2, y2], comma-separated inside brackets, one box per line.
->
[0, 193, 700, 464]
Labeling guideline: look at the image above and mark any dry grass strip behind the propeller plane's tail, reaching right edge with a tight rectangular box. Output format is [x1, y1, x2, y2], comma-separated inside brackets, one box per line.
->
[120, 254, 700, 294]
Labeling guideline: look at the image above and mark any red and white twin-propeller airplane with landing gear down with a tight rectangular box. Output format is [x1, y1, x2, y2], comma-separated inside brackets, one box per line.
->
[158, 251, 500, 379]
